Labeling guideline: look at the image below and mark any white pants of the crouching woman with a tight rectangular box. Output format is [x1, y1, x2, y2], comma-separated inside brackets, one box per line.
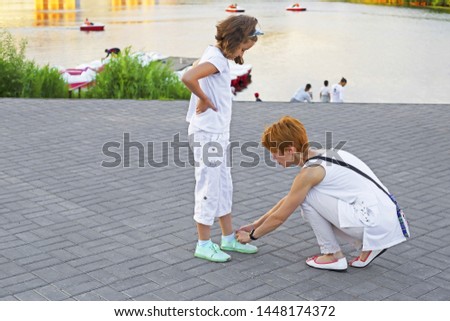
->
[301, 189, 364, 254]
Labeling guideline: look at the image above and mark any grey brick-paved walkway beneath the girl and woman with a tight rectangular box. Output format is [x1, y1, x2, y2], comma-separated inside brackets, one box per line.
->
[0, 99, 450, 300]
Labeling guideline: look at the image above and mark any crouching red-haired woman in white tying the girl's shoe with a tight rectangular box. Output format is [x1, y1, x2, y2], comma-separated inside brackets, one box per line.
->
[237, 116, 409, 271]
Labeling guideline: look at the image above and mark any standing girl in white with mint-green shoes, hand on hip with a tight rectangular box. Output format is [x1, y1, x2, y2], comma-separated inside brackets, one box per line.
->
[182, 15, 263, 262]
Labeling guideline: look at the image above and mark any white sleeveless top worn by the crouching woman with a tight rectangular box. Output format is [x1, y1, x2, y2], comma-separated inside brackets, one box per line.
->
[303, 150, 406, 251]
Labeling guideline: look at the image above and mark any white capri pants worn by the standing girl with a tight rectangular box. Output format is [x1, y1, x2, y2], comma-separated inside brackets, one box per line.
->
[189, 131, 233, 226]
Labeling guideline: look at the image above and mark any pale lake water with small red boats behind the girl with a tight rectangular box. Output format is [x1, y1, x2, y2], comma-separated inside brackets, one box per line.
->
[0, 0, 450, 103]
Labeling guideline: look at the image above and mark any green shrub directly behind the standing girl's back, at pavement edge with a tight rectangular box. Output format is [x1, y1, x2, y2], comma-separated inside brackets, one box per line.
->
[85, 48, 190, 100]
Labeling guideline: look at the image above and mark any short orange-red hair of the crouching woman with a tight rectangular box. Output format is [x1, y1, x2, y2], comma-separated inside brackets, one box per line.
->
[261, 116, 309, 159]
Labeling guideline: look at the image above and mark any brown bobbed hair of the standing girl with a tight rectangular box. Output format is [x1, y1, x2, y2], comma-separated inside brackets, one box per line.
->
[216, 15, 258, 65]
